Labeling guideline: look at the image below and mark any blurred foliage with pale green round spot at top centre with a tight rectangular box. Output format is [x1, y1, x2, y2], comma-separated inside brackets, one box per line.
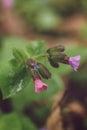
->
[16, 0, 61, 31]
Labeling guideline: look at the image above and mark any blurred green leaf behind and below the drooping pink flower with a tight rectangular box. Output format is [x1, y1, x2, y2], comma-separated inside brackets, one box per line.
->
[12, 74, 64, 111]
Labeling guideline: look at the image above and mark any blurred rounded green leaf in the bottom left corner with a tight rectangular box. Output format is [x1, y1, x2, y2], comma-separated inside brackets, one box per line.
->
[0, 112, 37, 130]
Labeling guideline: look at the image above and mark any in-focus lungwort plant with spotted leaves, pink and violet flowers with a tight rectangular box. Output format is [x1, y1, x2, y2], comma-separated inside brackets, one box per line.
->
[0, 38, 80, 98]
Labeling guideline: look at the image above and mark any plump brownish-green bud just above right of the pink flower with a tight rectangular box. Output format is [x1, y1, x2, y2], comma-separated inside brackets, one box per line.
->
[37, 63, 51, 79]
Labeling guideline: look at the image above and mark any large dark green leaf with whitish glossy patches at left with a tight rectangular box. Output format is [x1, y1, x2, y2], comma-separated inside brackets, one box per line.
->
[0, 59, 31, 98]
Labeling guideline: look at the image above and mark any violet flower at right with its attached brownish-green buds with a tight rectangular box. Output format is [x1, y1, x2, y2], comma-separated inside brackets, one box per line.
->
[47, 45, 80, 71]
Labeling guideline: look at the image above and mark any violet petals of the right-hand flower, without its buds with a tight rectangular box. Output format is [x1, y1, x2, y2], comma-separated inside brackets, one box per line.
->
[68, 55, 80, 71]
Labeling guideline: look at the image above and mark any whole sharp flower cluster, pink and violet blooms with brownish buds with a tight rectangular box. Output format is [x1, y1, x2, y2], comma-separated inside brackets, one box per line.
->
[26, 45, 80, 93]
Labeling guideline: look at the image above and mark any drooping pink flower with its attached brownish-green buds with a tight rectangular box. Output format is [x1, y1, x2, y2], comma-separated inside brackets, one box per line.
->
[27, 59, 51, 93]
